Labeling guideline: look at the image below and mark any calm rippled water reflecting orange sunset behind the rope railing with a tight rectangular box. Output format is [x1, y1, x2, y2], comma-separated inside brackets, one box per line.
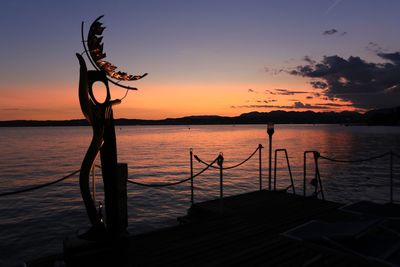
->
[0, 125, 400, 266]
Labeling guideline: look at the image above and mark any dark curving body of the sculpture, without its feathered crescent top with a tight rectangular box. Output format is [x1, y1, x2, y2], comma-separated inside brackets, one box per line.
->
[76, 54, 127, 238]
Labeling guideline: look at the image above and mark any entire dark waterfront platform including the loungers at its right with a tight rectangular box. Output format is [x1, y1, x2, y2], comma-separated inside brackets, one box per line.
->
[28, 190, 400, 267]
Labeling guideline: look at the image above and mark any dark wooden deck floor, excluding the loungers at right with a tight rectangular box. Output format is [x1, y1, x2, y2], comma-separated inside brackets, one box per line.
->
[28, 191, 388, 266]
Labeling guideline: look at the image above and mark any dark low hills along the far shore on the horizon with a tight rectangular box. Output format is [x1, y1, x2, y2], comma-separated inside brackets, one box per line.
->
[0, 107, 400, 127]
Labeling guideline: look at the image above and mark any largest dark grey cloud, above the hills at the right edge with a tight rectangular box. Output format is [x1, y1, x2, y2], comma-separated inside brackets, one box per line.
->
[289, 52, 400, 109]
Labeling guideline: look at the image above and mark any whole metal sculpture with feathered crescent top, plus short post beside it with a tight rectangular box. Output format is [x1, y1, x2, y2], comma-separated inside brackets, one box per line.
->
[76, 16, 147, 239]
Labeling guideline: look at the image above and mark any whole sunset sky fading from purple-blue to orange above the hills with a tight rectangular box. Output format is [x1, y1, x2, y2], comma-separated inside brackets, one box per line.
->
[0, 0, 400, 120]
